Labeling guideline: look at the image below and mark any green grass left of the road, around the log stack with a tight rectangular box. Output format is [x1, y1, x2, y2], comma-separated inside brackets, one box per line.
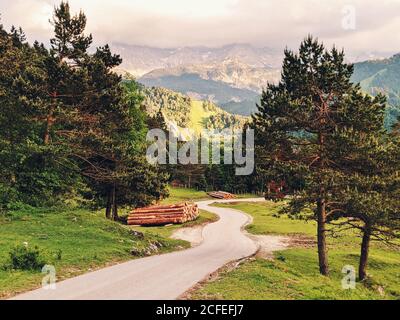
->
[0, 189, 216, 299]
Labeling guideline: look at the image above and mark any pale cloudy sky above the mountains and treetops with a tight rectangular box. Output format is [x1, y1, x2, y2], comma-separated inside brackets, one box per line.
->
[0, 0, 400, 52]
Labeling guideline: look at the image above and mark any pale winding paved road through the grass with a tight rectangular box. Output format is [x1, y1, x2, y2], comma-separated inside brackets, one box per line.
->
[14, 199, 263, 300]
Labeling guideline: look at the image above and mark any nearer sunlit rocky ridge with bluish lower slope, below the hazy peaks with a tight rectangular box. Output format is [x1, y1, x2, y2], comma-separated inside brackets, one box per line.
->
[139, 58, 280, 116]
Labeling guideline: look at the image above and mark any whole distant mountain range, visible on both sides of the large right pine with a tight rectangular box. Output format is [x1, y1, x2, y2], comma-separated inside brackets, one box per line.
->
[113, 44, 400, 126]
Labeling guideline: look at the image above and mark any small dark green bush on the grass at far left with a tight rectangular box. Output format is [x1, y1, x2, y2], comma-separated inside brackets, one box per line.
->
[8, 245, 46, 270]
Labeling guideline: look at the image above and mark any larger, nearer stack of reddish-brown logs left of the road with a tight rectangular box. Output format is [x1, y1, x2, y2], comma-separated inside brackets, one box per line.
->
[128, 202, 199, 226]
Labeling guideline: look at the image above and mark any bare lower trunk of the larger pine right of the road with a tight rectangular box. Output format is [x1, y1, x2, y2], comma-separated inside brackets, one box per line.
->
[317, 198, 329, 276]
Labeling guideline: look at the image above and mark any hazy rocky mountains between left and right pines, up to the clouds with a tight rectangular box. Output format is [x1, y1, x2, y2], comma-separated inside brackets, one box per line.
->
[113, 44, 283, 116]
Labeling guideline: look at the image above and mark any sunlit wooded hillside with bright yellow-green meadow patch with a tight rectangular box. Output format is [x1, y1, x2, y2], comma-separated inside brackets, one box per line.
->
[143, 87, 247, 133]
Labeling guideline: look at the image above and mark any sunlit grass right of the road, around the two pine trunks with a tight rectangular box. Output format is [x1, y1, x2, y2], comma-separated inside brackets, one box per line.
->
[192, 203, 400, 300]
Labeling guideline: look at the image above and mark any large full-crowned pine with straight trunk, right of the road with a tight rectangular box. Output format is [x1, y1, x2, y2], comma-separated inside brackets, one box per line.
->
[253, 36, 385, 275]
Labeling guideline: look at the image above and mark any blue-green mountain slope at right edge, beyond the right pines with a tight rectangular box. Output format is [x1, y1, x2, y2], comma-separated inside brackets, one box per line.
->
[352, 54, 400, 128]
